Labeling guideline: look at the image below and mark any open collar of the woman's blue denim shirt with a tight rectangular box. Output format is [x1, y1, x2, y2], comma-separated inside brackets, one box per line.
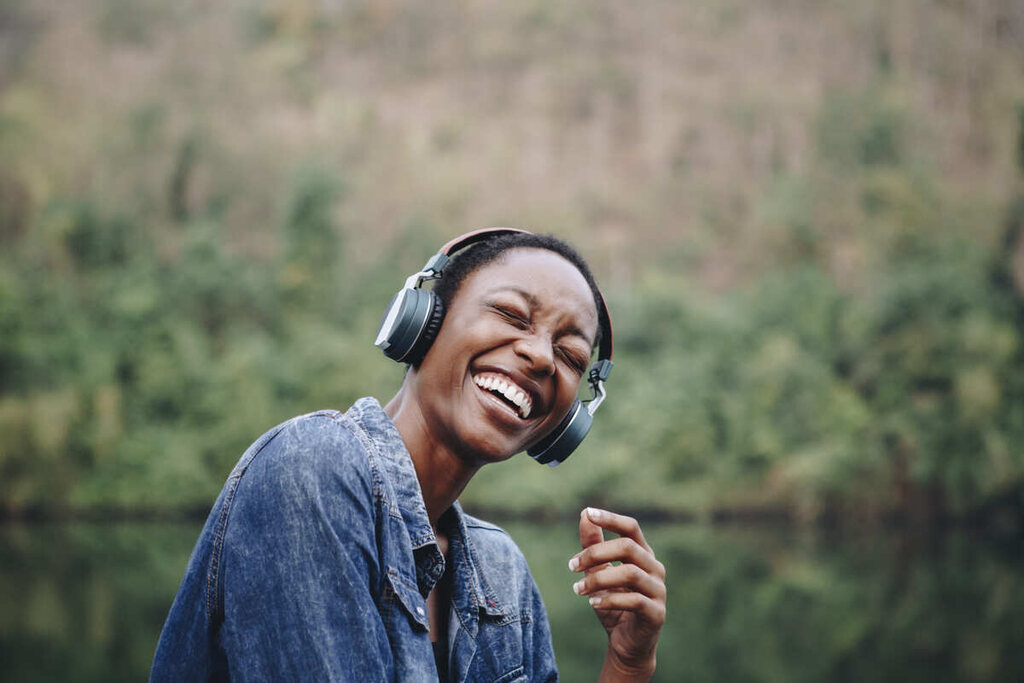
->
[348, 396, 509, 616]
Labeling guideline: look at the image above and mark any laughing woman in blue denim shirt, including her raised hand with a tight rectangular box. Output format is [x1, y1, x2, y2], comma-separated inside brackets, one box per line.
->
[152, 229, 666, 682]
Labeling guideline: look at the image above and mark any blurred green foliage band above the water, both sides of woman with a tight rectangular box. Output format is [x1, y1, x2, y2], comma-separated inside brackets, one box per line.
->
[0, 111, 1024, 518]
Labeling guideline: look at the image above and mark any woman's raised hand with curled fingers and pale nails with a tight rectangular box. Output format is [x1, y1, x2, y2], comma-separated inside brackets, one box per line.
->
[569, 508, 666, 681]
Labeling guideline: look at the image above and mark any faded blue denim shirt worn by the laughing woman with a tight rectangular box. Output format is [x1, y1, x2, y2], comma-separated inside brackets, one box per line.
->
[151, 398, 557, 683]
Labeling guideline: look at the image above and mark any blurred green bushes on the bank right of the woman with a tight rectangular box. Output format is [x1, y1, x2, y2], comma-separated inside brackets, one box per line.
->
[472, 121, 1024, 522]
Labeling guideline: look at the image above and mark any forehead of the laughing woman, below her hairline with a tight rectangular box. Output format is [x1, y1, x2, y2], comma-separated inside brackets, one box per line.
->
[456, 248, 597, 339]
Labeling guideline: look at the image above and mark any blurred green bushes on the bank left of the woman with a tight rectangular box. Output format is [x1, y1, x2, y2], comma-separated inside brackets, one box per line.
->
[0, 165, 403, 510]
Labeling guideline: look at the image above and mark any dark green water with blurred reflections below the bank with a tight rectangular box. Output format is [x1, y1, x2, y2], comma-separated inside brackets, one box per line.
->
[0, 523, 1024, 681]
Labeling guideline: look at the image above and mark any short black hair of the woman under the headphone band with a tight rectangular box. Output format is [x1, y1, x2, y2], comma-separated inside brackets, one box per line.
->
[433, 232, 608, 348]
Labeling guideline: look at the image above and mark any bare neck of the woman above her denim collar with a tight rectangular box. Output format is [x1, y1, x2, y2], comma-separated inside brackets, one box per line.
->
[384, 384, 480, 532]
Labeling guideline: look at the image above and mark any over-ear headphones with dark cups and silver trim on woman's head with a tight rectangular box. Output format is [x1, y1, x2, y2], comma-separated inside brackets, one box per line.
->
[374, 227, 612, 467]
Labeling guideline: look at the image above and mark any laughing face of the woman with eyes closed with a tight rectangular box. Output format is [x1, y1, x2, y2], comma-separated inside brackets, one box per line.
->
[414, 248, 598, 464]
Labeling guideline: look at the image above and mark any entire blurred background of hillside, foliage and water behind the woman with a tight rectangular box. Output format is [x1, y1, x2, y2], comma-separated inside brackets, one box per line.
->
[0, 0, 1024, 681]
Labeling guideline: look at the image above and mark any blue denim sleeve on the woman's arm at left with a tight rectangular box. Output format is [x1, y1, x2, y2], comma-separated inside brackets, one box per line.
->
[218, 415, 393, 681]
